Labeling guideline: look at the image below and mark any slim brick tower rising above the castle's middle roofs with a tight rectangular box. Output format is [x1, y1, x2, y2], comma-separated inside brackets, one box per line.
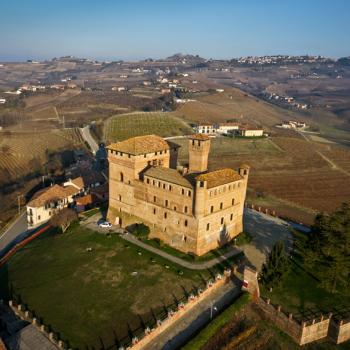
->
[188, 134, 210, 173]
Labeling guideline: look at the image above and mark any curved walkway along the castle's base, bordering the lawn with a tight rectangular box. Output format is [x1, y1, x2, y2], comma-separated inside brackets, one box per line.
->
[120, 233, 242, 270]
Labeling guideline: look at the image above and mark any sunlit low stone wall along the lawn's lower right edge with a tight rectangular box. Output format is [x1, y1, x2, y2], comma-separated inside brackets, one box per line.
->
[128, 270, 231, 350]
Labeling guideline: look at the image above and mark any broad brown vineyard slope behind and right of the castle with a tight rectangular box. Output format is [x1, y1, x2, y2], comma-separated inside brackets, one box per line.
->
[175, 137, 350, 216]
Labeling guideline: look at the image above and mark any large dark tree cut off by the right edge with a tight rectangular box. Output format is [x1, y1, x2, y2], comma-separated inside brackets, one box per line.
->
[302, 203, 350, 293]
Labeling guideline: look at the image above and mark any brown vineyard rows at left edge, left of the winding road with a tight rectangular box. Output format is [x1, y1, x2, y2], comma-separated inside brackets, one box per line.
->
[0, 129, 83, 181]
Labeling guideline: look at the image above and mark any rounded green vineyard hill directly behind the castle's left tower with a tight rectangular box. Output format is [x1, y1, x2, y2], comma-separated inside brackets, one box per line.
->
[104, 112, 192, 143]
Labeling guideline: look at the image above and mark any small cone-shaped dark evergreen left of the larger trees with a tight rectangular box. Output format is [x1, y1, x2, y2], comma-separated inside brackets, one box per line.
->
[261, 241, 290, 287]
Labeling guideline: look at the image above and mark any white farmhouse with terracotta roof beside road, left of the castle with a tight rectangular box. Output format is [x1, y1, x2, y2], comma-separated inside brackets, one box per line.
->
[27, 185, 80, 228]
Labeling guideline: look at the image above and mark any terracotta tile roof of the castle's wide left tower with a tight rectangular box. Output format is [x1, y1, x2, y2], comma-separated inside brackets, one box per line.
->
[107, 135, 169, 155]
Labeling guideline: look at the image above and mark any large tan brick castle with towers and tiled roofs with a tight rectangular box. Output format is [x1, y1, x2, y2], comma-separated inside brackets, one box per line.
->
[107, 134, 249, 255]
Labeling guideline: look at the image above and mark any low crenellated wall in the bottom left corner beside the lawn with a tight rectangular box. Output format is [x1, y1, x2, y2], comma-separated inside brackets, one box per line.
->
[9, 300, 68, 349]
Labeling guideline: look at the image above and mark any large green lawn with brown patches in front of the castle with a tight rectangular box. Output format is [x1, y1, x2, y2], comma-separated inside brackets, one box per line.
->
[0, 225, 217, 349]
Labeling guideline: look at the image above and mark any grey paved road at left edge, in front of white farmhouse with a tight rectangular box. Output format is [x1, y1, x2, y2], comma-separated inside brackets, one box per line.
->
[0, 211, 30, 256]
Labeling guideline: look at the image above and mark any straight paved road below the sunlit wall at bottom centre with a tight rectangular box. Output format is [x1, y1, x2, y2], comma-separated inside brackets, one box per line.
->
[144, 280, 241, 350]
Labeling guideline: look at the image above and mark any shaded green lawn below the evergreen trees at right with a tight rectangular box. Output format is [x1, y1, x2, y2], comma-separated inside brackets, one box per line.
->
[262, 232, 350, 320]
